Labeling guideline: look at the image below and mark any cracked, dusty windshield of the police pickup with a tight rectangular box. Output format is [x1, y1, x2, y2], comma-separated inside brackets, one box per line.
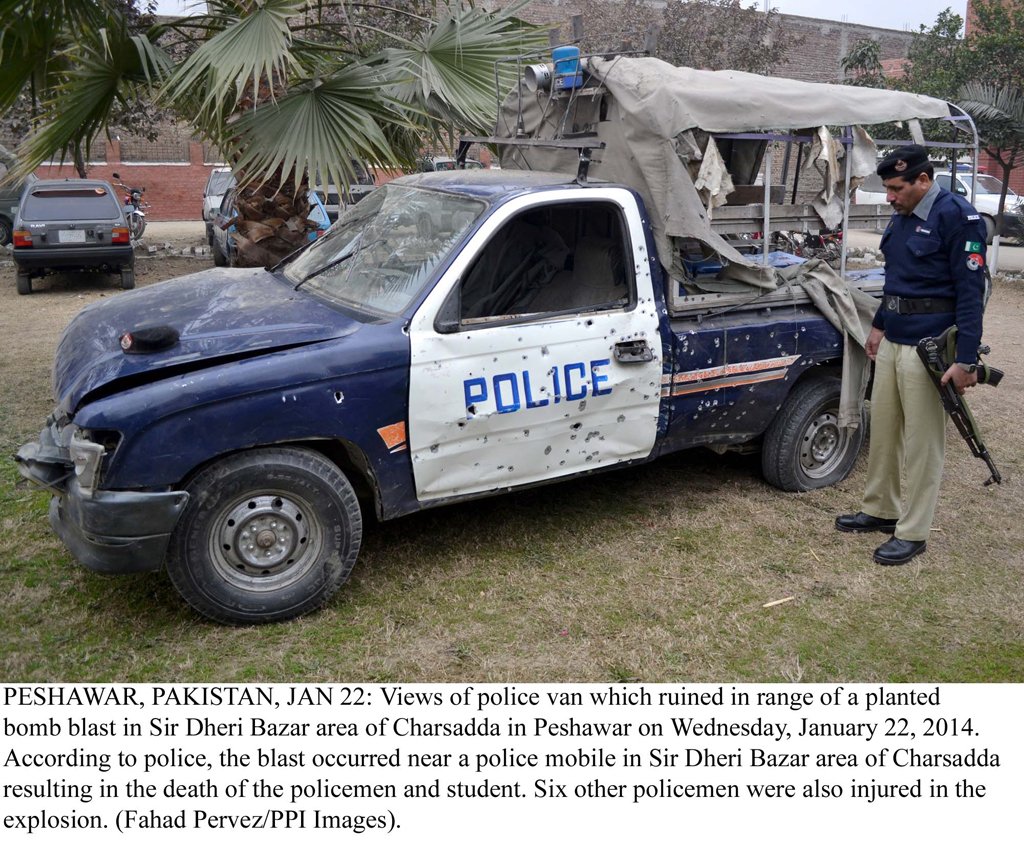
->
[285, 183, 485, 315]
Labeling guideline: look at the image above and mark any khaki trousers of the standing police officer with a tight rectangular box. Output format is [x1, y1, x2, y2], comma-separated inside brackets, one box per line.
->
[861, 339, 946, 541]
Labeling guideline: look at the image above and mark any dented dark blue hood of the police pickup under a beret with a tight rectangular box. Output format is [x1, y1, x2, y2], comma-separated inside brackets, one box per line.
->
[53, 269, 359, 414]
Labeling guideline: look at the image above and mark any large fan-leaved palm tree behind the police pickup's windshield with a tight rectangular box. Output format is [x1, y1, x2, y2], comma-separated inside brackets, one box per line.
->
[0, 0, 542, 265]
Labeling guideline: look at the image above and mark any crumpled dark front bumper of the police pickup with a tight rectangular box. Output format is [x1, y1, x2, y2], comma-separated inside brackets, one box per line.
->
[14, 423, 188, 573]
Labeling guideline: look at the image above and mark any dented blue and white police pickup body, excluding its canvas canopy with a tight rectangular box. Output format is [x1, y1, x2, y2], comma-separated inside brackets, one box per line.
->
[17, 56, 974, 623]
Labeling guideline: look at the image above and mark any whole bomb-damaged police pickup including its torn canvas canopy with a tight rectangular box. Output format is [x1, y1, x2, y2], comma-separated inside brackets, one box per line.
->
[17, 57, 963, 623]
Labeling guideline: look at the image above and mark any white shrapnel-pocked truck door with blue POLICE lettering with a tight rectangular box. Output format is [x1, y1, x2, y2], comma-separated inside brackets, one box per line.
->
[409, 187, 663, 500]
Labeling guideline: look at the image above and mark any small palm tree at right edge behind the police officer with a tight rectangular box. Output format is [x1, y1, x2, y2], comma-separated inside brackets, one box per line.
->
[957, 82, 1024, 240]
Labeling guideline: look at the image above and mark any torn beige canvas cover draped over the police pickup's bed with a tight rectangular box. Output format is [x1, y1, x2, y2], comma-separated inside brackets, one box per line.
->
[497, 57, 949, 291]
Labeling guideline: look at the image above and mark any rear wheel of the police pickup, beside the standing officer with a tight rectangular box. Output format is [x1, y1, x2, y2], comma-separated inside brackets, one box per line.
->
[761, 376, 867, 492]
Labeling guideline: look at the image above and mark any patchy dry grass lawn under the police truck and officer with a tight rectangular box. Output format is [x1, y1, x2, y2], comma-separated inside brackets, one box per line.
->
[0, 269, 1024, 683]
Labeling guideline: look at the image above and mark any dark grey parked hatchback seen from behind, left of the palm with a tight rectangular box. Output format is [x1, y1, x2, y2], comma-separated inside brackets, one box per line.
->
[13, 178, 135, 295]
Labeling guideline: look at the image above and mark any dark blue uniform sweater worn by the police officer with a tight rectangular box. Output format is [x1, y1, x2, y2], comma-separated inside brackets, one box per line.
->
[872, 188, 986, 363]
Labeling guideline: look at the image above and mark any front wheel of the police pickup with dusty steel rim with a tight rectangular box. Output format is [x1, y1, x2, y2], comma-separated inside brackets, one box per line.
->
[167, 448, 362, 624]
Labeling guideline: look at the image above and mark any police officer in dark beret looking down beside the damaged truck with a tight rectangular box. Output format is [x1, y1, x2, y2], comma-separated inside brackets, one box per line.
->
[836, 144, 986, 564]
